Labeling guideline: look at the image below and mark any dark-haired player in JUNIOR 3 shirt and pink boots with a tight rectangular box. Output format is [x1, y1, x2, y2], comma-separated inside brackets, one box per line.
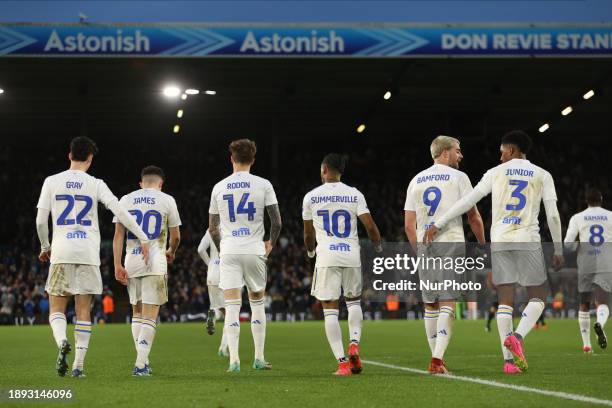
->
[425, 130, 564, 374]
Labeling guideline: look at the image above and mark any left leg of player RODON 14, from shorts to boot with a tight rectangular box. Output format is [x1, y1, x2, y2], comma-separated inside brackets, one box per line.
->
[219, 254, 244, 373]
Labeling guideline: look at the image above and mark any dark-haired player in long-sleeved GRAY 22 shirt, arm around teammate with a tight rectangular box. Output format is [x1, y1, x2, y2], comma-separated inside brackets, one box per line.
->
[36, 137, 149, 377]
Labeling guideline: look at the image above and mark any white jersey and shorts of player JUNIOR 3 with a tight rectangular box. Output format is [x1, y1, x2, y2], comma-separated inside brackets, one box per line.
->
[435, 159, 560, 286]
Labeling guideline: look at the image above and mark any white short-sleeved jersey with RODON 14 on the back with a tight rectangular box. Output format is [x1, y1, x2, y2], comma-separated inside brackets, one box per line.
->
[208, 171, 278, 256]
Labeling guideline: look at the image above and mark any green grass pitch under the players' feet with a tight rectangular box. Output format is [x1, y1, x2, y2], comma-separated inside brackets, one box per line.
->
[0, 320, 612, 408]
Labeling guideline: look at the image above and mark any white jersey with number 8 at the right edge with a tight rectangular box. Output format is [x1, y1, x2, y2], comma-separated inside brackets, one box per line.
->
[564, 207, 612, 273]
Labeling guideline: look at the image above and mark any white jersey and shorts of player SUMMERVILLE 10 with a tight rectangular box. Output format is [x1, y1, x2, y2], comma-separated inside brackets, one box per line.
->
[302, 182, 370, 300]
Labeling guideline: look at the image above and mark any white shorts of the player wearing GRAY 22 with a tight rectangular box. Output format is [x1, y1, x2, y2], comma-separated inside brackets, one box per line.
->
[45, 264, 102, 296]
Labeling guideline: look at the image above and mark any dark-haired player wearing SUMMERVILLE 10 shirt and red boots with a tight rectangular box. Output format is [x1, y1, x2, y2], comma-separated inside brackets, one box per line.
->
[302, 153, 382, 376]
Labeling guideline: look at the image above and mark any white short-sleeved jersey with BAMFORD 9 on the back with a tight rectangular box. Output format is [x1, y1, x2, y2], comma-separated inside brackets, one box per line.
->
[404, 164, 472, 242]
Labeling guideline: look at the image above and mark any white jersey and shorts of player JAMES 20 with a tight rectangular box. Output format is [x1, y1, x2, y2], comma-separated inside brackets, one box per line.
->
[113, 188, 181, 305]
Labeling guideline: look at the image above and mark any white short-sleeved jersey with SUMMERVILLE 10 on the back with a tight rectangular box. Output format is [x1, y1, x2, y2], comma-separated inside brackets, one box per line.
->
[302, 182, 370, 267]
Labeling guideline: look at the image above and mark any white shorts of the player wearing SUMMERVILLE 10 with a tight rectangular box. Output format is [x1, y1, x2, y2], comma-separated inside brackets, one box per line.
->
[310, 266, 363, 301]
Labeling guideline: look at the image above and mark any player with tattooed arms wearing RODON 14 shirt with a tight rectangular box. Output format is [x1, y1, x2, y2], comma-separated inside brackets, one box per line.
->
[208, 139, 282, 373]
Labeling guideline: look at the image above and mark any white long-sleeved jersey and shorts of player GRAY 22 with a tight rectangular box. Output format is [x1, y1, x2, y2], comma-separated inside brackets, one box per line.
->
[37, 170, 147, 296]
